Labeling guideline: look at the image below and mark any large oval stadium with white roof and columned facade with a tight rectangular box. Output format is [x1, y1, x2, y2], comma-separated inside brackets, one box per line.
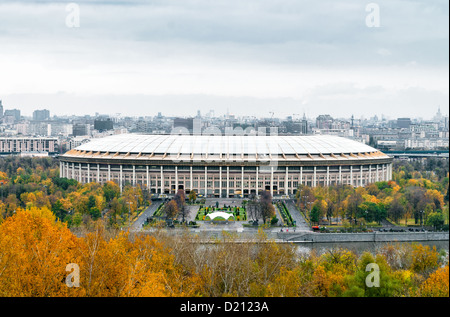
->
[59, 134, 392, 198]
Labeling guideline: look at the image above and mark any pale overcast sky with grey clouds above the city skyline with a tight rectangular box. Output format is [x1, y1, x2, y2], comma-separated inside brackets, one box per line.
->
[0, 0, 449, 119]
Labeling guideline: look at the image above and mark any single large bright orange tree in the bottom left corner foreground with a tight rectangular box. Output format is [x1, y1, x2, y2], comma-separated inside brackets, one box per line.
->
[0, 207, 79, 297]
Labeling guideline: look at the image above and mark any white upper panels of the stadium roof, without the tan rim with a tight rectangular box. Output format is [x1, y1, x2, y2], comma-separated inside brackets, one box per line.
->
[76, 134, 378, 156]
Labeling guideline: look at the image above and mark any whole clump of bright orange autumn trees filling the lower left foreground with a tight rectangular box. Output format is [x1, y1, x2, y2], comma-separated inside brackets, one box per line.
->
[0, 207, 201, 297]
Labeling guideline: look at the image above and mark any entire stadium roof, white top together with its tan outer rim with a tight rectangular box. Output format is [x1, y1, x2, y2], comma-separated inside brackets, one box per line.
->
[60, 134, 389, 164]
